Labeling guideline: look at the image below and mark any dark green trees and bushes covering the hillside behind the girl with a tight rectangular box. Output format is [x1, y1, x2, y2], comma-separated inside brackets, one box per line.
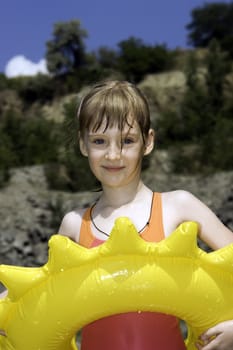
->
[0, 2, 233, 191]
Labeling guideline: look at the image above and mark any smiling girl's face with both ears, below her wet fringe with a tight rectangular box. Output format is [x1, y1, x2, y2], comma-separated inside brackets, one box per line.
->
[80, 117, 154, 188]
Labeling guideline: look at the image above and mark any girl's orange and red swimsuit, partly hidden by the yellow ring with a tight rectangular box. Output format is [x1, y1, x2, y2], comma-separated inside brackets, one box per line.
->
[79, 193, 186, 350]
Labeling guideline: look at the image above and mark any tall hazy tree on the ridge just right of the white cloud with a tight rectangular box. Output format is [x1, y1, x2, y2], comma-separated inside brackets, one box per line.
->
[46, 20, 88, 75]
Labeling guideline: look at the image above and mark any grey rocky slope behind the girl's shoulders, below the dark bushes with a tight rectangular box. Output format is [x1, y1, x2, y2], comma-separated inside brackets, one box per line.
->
[0, 151, 233, 288]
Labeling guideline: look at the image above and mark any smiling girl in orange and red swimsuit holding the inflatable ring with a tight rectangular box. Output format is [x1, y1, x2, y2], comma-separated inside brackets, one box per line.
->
[59, 81, 233, 350]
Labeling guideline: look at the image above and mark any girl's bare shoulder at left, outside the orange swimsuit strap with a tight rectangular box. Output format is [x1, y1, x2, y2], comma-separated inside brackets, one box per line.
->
[58, 209, 86, 242]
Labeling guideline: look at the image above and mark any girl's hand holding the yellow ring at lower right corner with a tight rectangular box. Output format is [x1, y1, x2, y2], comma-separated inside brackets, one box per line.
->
[196, 320, 233, 350]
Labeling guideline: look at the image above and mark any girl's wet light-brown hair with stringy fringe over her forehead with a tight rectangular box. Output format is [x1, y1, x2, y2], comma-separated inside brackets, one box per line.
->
[78, 80, 150, 142]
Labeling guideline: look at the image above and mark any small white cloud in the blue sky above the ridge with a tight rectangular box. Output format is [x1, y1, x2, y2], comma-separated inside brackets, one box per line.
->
[5, 55, 48, 78]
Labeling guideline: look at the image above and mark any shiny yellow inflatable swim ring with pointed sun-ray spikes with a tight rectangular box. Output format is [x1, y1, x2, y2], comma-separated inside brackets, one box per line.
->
[0, 218, 233, 350]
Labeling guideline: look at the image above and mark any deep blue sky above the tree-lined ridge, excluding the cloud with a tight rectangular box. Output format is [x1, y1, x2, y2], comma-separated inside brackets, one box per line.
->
[0, 0, 229, 76]
